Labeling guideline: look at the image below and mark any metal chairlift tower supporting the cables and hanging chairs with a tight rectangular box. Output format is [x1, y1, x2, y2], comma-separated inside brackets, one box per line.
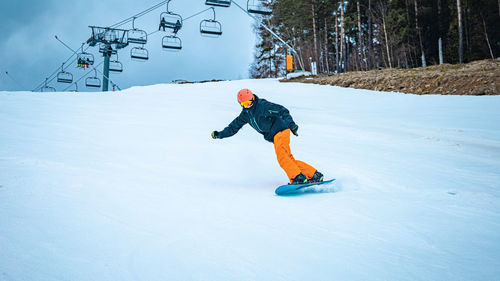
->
[87, 26, 128, 92]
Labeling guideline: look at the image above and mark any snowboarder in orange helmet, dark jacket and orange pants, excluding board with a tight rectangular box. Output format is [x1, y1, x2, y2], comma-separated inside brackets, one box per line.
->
[212, 89, 323, 184]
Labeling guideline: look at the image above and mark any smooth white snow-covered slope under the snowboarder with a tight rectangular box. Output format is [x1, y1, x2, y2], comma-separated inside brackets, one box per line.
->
[0, 80, 500, 281]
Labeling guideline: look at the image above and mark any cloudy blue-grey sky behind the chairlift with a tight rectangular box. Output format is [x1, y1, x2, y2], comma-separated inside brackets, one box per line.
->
[0, 0, 255, 91]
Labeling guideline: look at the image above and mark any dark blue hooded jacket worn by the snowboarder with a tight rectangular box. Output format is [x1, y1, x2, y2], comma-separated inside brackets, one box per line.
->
[219, 96, 295, 142]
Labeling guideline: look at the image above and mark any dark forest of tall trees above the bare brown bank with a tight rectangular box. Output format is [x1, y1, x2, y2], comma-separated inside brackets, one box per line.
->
[250, 0, 500, 78]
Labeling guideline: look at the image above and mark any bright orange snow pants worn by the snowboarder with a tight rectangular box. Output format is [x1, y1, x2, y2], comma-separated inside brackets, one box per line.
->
[274, 129, 316, 182]
